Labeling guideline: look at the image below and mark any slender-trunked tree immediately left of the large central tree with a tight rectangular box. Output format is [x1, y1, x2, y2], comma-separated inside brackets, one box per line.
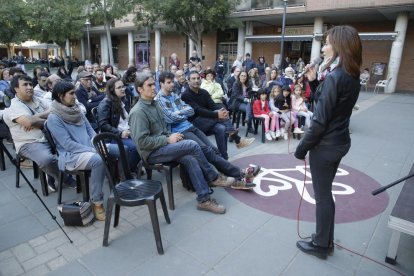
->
[89, 0, 137, 64]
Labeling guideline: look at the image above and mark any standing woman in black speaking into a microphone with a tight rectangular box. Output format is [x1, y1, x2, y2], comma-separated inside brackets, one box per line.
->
[295, 26, 362, 259]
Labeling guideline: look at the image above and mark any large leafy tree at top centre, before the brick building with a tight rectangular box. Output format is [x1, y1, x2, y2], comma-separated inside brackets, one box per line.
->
[136, 0, 239, 56]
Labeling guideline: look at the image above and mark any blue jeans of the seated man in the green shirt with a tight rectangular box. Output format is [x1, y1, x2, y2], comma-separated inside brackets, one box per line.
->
[147, 140, 218, 202]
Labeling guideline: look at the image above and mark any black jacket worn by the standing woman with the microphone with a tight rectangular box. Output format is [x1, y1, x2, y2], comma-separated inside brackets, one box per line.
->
[295, 68, 360, 159]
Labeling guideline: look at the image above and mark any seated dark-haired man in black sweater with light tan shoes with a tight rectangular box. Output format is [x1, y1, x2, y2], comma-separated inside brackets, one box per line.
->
[181, 71, 254, 160]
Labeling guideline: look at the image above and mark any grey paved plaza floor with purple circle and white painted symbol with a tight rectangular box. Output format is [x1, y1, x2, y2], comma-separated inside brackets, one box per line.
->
[0, 92, 414, 276]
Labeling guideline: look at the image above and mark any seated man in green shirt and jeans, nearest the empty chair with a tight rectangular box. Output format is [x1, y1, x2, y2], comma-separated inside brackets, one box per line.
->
[129, 73, 235, 214]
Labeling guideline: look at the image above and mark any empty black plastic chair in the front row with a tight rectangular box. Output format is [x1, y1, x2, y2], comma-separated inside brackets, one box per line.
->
[92, 133, 171, 254]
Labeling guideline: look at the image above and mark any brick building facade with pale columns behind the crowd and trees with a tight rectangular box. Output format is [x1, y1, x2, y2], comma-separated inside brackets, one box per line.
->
[70, 0, 414, 92]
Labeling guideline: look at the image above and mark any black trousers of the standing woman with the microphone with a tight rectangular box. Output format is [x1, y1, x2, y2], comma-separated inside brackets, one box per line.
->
[309, 144, 351, 247]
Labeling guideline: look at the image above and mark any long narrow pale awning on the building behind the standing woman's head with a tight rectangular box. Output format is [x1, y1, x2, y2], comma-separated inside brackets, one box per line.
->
[244, 32, 398, 42]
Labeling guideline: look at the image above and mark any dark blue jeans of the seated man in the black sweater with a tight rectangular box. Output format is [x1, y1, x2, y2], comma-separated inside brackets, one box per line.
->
[192, 116, 235, 160]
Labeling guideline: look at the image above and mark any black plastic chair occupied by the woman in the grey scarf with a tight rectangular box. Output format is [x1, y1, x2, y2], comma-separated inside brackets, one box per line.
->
[43, 121, 91, 204]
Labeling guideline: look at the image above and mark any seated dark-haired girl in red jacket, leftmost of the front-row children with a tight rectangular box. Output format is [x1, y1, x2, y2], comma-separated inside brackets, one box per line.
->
[253, 88, 280, 141]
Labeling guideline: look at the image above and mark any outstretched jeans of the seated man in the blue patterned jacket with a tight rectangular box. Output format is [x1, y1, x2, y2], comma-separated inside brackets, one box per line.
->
[183, 127, 242, 179]
